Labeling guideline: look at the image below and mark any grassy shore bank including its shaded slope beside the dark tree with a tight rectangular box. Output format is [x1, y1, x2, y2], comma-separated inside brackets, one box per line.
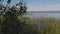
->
[0, 16, 60, 34]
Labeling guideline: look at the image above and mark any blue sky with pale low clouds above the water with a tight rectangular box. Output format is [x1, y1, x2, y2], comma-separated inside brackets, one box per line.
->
[1, 0, 60, 11]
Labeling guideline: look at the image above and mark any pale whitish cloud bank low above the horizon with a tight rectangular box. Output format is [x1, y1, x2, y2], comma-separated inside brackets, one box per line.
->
[28, 4, 60, 11]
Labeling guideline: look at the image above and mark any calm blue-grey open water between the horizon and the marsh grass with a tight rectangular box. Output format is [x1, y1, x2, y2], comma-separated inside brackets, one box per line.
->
[28, 11, 60, 18]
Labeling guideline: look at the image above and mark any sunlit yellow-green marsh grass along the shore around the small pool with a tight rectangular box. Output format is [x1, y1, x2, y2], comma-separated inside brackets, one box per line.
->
[0, 15, 60, 34]
